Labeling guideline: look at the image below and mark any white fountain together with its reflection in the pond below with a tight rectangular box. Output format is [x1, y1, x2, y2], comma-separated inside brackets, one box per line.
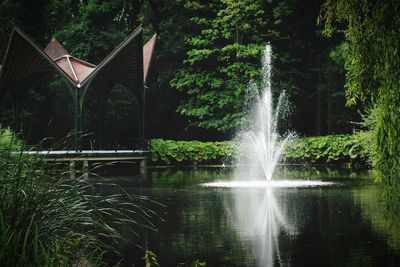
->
[202, 45, 334, 267]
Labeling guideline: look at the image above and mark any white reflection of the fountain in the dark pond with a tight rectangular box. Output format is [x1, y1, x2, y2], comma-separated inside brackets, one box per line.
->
[227, 188, 295, 267]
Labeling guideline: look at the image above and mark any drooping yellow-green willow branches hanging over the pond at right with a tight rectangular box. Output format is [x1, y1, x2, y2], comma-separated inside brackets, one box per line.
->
[322, 0, 400, 203]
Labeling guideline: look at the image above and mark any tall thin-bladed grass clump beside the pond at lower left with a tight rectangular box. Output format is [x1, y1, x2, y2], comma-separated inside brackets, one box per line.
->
[0, 130, 159, 266]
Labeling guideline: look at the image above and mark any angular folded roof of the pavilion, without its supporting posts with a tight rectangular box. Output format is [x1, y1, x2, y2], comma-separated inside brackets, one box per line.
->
[0, 27, 156, 96]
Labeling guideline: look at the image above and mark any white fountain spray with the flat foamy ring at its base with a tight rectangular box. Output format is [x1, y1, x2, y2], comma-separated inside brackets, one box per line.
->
[202, 44, 333, 187]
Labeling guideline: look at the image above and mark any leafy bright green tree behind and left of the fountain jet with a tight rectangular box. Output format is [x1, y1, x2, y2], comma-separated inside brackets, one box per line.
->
[171, 0, 300, 132]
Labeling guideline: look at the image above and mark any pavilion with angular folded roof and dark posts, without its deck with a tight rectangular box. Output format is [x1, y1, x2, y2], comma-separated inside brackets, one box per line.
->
[0, 27, 156, 151]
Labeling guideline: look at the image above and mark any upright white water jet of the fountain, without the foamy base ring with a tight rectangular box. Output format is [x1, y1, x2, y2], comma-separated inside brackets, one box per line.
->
[235, 45, 292, 181]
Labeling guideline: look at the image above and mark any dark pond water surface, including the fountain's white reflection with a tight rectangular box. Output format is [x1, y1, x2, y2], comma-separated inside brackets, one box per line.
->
[95, 167, 400, 266]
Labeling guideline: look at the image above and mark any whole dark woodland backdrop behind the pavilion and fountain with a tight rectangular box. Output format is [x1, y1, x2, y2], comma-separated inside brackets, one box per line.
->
[0, 0, 357, 148]
